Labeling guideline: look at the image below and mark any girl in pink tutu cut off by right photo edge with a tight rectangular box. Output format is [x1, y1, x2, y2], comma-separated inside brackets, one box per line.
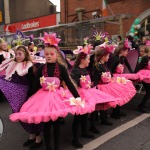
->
[136, 42, 150, 113]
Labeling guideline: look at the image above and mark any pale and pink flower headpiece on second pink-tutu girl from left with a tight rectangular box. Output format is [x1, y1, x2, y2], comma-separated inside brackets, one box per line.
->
[73, 44, 93, 54]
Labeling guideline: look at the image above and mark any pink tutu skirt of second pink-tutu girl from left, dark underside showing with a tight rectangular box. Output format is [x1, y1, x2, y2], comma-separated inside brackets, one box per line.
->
[78, 88, 119, 110]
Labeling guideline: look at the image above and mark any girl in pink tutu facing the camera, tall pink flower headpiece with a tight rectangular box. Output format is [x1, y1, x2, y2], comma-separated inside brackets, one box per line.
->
[10, 33, 91, 150]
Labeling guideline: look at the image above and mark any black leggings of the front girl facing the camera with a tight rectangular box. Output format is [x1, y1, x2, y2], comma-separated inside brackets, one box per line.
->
[43, 119, 60, 150]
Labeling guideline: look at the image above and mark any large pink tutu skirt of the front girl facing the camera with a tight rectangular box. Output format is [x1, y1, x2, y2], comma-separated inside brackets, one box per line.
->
[10, 88, 95, 124]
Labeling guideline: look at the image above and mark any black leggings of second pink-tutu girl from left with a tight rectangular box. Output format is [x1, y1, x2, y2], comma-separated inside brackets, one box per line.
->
[72, 114, 88, 141]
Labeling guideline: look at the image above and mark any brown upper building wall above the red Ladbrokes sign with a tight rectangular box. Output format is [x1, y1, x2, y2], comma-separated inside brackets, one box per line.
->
[9, 0, 56, 23]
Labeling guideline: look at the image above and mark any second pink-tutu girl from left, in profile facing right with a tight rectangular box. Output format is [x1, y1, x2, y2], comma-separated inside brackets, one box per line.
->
[71, 45, 119, 148]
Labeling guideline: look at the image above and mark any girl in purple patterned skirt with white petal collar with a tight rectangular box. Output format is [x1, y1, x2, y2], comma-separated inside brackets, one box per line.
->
[0, 46, 42, 147]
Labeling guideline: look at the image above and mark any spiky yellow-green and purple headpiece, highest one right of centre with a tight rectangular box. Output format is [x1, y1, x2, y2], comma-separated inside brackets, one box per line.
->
[93, 31, 108, 41]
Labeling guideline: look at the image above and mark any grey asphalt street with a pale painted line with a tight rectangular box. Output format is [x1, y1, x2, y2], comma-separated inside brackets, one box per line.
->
[0, 94, 150, 150]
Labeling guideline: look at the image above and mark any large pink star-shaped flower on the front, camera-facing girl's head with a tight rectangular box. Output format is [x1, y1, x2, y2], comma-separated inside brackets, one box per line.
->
[40, 32, 61, 47]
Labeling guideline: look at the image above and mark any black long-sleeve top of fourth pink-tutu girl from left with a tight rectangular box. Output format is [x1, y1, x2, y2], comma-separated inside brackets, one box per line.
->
[109, 55, 133, 73]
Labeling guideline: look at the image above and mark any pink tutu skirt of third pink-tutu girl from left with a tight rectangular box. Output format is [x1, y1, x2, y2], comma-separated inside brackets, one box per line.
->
[98, 80, 136, 108]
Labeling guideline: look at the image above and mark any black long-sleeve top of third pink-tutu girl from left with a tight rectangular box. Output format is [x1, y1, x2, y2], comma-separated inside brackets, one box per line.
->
[92, 63, 113, 86]
